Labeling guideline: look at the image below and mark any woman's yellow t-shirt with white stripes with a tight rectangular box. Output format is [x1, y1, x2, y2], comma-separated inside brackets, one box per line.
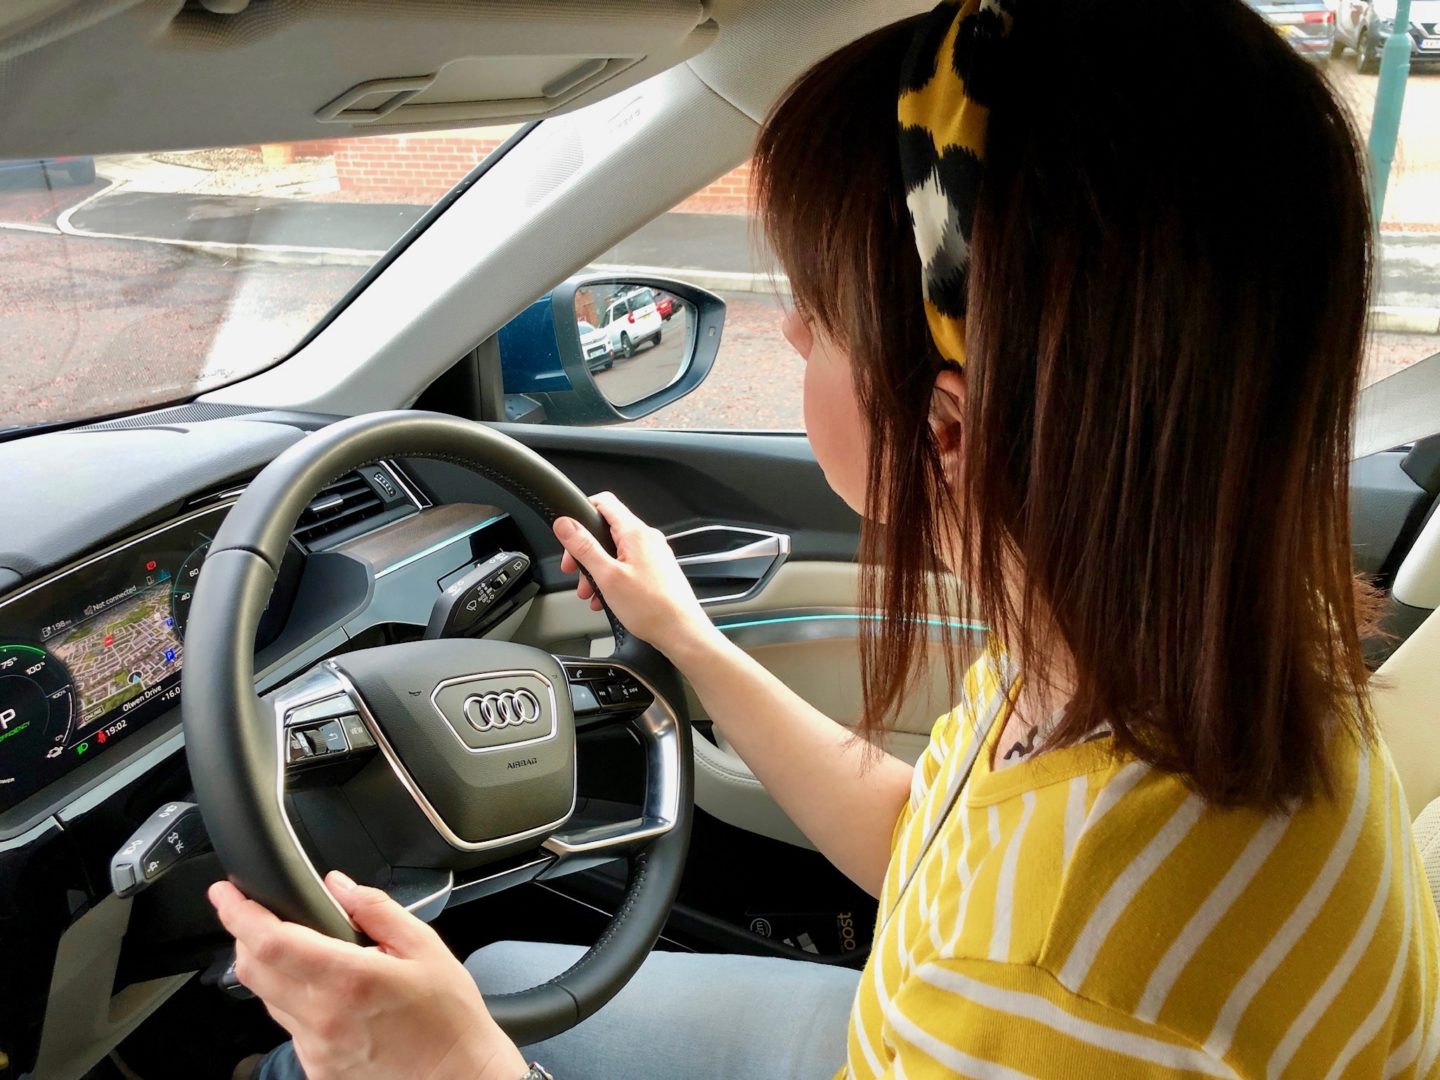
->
[841, 661, 1440, 1080]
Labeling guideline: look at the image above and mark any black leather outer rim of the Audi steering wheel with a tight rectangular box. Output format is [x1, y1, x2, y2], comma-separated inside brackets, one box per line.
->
[181, 410, 694, 1043]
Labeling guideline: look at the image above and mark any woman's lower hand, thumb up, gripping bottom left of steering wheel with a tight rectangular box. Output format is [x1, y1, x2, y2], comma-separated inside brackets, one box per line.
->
[209, 873, 527, 1080]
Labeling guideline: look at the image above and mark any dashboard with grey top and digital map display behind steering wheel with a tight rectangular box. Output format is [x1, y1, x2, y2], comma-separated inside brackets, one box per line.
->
[0, 406, 570, 1077]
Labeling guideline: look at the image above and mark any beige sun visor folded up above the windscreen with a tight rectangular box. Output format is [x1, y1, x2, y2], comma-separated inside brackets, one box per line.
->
[0, 0, 719, 158]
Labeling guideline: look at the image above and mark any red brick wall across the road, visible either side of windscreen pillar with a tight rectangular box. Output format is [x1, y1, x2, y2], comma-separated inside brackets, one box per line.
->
[277, 130, 750, 213]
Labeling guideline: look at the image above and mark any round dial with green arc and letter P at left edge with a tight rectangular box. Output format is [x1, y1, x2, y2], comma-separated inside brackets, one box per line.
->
[0, 645, 75, 788]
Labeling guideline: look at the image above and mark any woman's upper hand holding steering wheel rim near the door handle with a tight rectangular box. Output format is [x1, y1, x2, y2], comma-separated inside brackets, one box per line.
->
[554, 491, 719, 665]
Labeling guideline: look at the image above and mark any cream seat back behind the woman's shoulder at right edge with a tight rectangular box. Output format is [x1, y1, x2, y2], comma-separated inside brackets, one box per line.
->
[1371, 613, 1440, 816]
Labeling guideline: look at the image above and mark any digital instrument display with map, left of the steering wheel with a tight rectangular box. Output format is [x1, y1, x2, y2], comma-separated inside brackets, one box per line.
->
[0, 505, 304, 809]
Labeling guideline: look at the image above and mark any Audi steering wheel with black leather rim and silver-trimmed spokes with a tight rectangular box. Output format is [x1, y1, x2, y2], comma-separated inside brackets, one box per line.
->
[181, 410, 694, 1044]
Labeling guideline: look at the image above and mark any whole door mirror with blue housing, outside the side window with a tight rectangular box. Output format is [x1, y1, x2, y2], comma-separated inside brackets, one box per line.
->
[498, 274, 724, 426]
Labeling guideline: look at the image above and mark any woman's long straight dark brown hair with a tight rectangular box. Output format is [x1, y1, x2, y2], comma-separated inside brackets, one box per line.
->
[756, 0, 1372, 808]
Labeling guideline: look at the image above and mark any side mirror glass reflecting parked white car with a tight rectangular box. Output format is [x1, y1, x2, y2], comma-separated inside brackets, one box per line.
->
[575, 281, 696, 406]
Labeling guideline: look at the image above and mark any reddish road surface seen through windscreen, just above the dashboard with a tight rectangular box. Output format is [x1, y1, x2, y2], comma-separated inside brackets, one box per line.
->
[0, 230, 361, 426]
